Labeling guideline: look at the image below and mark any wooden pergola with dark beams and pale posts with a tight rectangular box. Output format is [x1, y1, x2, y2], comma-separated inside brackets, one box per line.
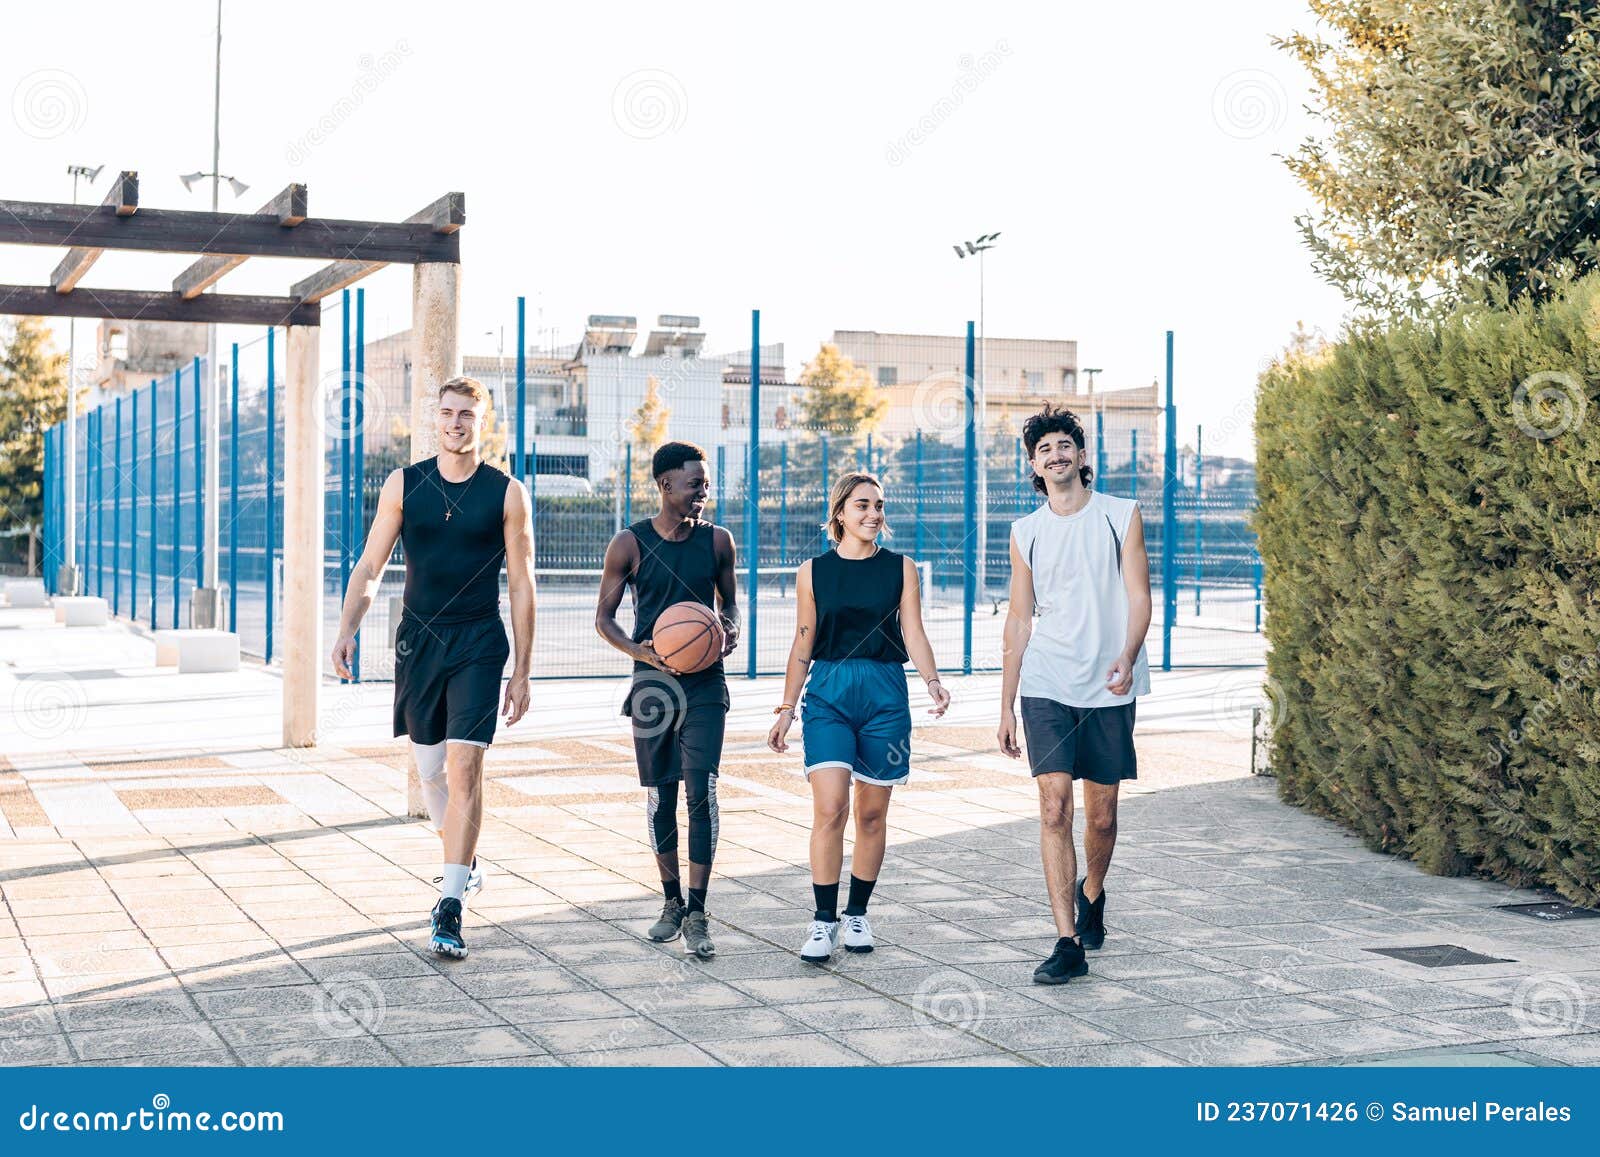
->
[0, 173, 466, 747]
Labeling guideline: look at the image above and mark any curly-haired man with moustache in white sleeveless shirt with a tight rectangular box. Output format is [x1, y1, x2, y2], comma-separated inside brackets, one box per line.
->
[998, 405, 1150, 984]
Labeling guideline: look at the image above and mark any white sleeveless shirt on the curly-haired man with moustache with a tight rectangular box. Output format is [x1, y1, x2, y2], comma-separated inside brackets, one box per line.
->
[1011, 491, 1150, 707]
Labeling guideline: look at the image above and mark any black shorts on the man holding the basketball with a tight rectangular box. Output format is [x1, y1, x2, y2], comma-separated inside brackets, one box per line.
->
[622, 671, 730, 787]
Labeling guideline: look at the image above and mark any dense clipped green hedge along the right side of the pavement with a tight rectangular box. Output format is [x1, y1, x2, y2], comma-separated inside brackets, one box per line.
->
[1256, 277, 1600, 904]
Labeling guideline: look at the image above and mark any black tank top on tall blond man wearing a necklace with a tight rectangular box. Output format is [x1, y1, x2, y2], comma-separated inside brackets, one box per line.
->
[400, 458, 510, 624]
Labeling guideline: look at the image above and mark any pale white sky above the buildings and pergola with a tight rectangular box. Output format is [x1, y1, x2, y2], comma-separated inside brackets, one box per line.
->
[0, 0, 1346, 454]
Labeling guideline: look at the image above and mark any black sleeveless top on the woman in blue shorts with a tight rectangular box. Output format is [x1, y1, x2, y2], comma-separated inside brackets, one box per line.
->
[811, 547, 909, 663]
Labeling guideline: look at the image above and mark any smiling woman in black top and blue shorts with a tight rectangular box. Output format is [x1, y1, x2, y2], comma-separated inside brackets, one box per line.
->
[766, 474, 950, 963]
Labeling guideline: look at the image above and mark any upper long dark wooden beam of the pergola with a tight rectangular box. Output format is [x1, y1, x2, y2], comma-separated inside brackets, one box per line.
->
[0, 200, 461, 264]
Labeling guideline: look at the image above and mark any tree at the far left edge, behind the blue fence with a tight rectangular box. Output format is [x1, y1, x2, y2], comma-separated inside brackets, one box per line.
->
[0, 317, 67, 569]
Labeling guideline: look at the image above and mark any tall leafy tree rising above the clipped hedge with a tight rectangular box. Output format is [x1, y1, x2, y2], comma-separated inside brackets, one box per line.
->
[1274, 0, 1600, 314]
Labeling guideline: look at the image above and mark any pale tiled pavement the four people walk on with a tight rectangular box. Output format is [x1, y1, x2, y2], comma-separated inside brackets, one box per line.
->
[0, 604, 1600, 1064]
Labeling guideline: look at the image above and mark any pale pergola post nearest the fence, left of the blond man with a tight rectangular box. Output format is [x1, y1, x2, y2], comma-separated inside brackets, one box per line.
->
[278, 325, 323, 747]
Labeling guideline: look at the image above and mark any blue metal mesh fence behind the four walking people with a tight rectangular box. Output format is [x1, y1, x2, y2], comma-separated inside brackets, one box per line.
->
[43, 299, 1262, 679]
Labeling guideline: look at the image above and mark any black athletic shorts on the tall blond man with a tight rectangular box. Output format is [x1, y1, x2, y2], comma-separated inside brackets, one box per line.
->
[395, 615, 510, 747]
